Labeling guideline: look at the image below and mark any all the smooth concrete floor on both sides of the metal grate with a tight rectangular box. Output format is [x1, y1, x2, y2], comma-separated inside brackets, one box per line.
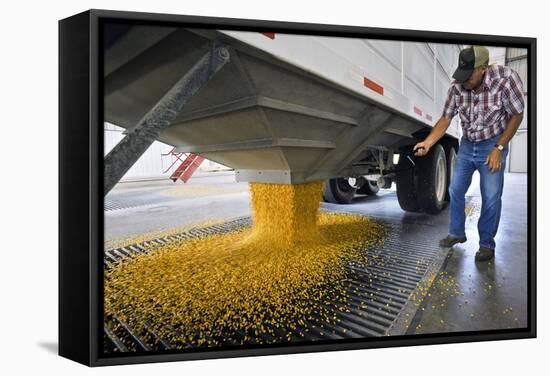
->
[105, 172, 527, 334]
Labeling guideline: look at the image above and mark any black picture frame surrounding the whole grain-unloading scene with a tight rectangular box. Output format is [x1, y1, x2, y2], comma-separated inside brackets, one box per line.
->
[59, 10, 537, 366]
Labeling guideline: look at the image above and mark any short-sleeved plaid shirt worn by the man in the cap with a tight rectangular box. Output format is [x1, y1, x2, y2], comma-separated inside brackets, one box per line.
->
[443, 65, 525, 141]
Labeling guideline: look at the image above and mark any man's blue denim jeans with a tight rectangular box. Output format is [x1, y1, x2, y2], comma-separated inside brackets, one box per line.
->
[449, 135, 508, 249]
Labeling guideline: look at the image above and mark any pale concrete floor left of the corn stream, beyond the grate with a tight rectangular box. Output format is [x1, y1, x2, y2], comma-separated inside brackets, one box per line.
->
[104, 172, 250, 241]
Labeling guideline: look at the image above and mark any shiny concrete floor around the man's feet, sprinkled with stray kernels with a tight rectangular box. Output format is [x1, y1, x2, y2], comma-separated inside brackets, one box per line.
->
[408, 174, 528, 334]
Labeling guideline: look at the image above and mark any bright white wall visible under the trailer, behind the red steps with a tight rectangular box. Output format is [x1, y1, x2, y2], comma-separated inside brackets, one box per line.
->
[103, 123, 231, 182]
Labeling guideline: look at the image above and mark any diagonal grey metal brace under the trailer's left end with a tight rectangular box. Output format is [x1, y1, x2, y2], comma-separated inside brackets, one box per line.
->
[103, 43, 229, 196]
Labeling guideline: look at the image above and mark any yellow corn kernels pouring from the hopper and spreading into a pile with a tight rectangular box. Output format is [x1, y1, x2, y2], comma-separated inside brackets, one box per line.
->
[104, 182, 385, 348]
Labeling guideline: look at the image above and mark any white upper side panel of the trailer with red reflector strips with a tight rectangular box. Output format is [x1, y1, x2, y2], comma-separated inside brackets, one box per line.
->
[221, 30, 461, 138]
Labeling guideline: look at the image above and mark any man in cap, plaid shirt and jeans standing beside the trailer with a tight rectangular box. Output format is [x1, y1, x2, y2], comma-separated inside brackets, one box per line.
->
[414, 46, 525, 261]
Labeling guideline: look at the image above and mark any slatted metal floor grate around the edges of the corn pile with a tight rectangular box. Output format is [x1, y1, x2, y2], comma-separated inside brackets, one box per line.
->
[104, 218, 448, 352]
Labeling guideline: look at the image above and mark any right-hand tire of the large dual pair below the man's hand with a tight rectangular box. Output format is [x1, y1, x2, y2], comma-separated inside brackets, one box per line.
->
[416, 144, 447, 214]
